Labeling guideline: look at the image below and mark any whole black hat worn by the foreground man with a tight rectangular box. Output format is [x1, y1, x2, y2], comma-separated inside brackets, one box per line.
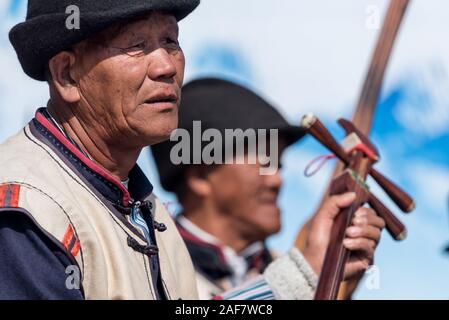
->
[9, 0, 200, 81]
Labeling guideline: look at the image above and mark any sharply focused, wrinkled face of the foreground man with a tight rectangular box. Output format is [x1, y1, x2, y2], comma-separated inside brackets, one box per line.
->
[73, 12, 185, 148]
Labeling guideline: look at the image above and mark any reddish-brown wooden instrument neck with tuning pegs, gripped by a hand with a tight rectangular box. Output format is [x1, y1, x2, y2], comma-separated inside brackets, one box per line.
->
[302, 114, 415, 300]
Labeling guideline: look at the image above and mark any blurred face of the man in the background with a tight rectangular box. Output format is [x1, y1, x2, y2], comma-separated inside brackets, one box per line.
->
[207, 143, 285, 241]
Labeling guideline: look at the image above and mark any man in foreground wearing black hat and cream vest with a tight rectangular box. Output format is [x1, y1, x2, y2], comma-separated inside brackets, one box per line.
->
[0, 0, 384, 299]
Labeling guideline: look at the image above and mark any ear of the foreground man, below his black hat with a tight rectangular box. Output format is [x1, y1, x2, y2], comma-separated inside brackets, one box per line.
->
[48, 51, 80, 103]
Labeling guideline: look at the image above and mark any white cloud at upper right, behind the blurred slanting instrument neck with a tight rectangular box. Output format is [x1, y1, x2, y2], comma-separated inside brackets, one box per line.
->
[181, 0, 449, 121]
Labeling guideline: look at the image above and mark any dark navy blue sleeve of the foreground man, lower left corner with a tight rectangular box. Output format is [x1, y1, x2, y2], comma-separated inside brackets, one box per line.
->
[0, 209, 84, 300]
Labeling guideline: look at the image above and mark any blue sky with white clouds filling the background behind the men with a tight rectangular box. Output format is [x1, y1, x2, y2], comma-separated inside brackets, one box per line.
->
[0, 0, 449, 299]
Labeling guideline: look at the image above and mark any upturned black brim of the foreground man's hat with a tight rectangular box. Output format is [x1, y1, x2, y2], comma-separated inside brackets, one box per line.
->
[9, 0, 200, 81]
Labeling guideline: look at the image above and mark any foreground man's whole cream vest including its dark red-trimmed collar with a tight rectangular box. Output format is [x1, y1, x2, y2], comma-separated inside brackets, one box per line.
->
[0, 110, 198, 299]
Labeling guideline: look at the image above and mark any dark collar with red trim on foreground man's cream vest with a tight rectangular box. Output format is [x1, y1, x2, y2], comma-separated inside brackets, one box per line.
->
[30, 108, 153, 207]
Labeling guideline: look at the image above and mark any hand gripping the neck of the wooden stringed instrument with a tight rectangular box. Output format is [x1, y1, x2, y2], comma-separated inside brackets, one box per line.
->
[303, 193, 385, 280]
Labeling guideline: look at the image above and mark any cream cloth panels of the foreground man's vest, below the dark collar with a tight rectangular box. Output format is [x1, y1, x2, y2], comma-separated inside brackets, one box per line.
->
[0, 115, 198, 299]
